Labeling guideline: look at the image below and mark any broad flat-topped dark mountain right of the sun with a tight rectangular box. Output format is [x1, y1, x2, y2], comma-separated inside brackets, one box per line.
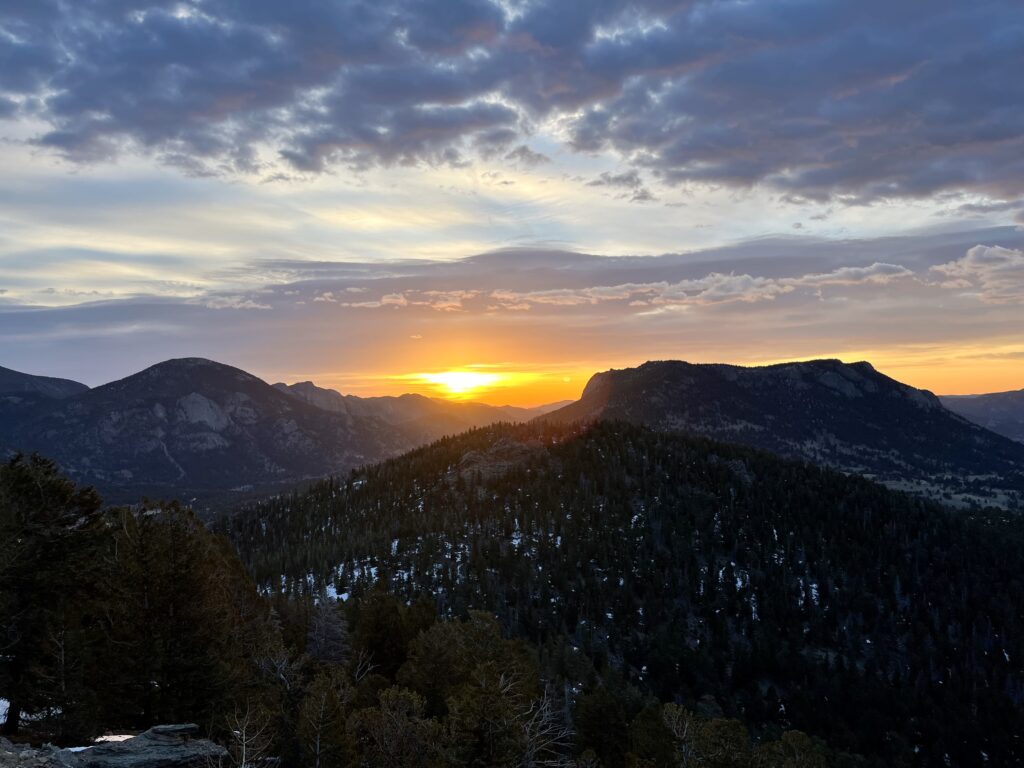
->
[541, 360, 1024, 506]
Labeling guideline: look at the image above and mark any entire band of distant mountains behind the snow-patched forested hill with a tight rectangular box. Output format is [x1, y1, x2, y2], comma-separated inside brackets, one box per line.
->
[0, 358, 1024, 507]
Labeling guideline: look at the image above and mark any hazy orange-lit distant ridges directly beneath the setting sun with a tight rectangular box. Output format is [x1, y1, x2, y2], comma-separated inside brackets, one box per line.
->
[273, 381, 567, 444]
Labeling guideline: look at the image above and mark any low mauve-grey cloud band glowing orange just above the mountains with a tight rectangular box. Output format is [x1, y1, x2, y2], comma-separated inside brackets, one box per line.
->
[6, 233, 1024, 391]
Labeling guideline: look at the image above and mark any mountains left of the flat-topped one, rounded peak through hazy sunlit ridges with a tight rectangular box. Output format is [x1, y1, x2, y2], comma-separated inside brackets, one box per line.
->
[0, 357, 561, 508]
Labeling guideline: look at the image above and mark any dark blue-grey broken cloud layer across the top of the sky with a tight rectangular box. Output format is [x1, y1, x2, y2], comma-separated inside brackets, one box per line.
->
[0, 0, 1024, 198]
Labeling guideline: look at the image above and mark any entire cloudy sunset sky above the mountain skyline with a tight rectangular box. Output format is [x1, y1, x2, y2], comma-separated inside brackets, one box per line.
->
[0, 0, 1024, 404]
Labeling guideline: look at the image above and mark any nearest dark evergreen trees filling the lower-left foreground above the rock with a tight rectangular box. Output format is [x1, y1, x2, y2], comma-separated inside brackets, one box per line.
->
[0, 457, 847, 768]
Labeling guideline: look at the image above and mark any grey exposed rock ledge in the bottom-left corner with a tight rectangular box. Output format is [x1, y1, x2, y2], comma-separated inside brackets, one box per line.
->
[0, 724, 227, 768]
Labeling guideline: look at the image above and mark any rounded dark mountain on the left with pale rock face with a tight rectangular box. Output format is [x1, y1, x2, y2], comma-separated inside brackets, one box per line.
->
[0, 358, 411, 501]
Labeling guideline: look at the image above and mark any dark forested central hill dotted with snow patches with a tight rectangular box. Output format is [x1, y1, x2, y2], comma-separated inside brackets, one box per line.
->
[225, 423, 1024, 766]
